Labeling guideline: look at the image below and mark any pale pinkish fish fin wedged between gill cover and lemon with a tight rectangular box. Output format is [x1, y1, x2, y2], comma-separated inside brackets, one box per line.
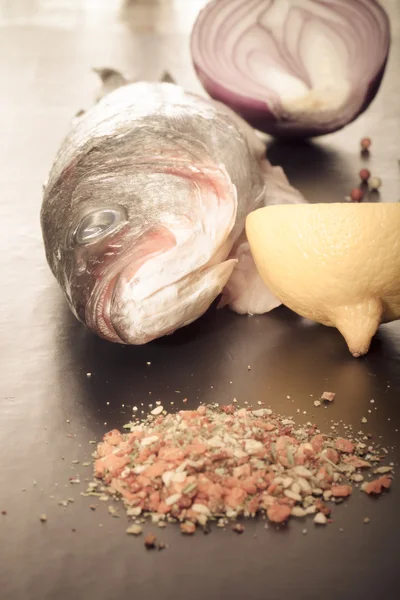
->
[218, 234, 282, 315]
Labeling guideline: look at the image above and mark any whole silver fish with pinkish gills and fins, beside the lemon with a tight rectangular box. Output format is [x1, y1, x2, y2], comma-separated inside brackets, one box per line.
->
[41, 82, 303, 344]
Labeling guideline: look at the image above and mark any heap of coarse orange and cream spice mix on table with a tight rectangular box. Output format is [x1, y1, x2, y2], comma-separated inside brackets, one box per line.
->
[85, 405, 392, 535]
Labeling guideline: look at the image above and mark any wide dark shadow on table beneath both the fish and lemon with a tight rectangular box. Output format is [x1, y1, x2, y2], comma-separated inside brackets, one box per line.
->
[54, 288, 400, 427]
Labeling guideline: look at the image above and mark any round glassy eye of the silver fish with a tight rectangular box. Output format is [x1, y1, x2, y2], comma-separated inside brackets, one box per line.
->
[74, 208, 125, 245]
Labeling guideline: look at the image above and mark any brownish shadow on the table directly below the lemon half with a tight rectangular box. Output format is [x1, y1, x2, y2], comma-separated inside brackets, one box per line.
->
[249, 320, 400, 428]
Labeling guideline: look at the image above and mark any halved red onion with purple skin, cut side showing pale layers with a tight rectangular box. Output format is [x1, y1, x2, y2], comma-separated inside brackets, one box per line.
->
[191, 0, 390, 137]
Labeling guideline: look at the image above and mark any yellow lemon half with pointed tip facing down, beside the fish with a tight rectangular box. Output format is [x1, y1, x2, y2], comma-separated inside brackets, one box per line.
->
[246, 203, 400, 357]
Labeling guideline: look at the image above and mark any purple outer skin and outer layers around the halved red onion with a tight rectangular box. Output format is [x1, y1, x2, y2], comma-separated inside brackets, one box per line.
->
[191, 0, 391, 138]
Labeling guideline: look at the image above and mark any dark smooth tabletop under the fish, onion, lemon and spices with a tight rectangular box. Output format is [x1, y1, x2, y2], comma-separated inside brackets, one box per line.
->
[0, 0, 400, 600]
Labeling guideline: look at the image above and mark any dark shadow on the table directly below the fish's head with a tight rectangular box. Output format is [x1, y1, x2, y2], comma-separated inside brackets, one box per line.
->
[58, 305, 300, 413]
